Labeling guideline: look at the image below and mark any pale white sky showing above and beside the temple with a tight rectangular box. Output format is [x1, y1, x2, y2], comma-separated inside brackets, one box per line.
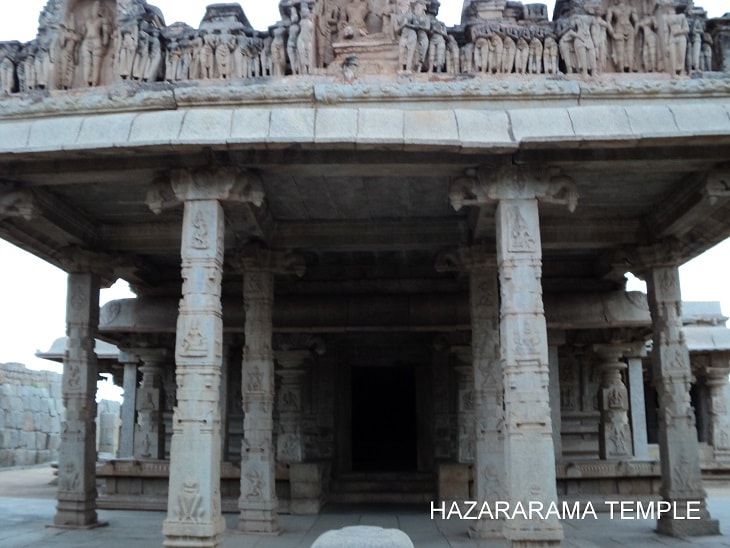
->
[0, 0, 730, 376]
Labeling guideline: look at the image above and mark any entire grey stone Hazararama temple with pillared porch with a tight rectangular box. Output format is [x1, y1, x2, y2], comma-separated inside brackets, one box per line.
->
[0, 0, 730, 547]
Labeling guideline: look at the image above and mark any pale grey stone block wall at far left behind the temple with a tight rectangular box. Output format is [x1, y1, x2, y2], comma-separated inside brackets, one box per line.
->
[0, 363, 63, 468]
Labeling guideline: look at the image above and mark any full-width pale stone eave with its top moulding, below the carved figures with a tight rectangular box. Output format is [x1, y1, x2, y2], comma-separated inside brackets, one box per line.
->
[0, 77, 730, 159]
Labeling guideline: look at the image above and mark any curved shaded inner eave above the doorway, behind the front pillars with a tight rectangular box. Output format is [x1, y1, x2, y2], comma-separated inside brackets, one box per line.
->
[100, 291, 651, 336]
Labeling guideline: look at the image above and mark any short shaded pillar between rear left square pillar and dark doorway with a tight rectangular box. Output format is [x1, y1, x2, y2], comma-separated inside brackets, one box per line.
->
[275, 350, 310, 464]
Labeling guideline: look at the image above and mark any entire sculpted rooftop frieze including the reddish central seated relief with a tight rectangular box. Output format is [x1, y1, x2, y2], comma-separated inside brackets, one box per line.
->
[0, 0, 727, 96]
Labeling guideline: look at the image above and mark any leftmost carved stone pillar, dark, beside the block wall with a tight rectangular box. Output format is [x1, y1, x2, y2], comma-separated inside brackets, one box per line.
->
[53, 273, 100, 528]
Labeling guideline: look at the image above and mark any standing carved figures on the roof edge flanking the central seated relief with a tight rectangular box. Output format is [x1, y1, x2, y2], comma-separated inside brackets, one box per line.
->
[0, 0, 712, 95]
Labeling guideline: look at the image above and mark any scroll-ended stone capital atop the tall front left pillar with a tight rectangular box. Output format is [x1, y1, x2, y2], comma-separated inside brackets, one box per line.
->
[147, 167, 265, 214]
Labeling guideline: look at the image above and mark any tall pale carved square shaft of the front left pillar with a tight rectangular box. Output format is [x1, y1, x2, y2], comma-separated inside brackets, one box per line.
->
[163, 196, 225, 546]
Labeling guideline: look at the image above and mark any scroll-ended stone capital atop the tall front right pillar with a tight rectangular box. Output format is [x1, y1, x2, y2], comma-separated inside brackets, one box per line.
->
[449, 162, 579, 213]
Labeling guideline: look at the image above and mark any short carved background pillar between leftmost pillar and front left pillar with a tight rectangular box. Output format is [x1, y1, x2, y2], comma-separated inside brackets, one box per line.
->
[134, 348, 167, 459]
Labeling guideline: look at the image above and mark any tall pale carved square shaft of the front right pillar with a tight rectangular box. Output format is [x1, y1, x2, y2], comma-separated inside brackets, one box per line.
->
[496, 196, 563, 545]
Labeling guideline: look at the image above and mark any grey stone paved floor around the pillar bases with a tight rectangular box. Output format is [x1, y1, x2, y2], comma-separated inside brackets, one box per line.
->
[0, 467, 730, 548]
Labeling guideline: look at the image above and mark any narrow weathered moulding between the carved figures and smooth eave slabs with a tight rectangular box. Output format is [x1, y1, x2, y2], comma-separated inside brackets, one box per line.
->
[0, 74, 730, 119]
